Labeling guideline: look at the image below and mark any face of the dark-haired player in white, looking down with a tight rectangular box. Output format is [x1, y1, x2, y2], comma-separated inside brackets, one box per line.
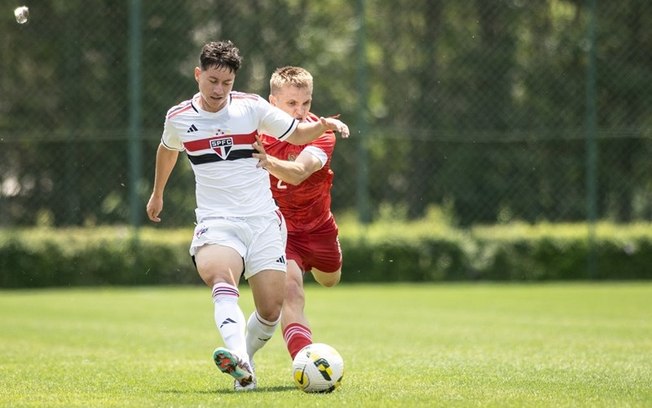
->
[195, 67, 235, 112]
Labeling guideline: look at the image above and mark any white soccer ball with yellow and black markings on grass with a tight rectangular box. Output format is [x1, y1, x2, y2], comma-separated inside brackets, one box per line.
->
[292, 343, 344, 393]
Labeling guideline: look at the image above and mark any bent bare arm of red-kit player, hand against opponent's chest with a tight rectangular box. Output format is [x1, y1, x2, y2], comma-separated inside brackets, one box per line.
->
[253, 138, 323, 186]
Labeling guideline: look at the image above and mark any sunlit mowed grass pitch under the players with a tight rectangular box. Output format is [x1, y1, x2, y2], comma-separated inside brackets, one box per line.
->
[0, 283, 652, 408]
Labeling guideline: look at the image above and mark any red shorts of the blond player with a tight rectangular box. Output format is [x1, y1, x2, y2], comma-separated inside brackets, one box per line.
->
[285, 217, 342, 273]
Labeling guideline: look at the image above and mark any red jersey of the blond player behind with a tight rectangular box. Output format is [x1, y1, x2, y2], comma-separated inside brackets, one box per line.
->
[261, 114, 335, 232]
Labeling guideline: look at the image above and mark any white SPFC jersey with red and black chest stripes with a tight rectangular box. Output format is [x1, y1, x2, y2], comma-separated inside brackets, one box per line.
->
[161, 92, 298, 222]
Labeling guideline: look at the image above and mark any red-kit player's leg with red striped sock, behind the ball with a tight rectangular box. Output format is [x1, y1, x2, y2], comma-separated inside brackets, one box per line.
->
[281, 260, 312, 359]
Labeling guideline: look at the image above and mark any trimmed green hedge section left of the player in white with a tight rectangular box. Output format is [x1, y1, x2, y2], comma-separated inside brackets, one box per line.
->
[0, 228, 201, 288]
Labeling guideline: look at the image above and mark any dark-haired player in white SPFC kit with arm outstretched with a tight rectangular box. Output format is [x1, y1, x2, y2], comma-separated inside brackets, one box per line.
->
[147, 41, 349, 390]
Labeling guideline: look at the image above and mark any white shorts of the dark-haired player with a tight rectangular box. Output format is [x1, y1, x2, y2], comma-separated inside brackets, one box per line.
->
[190, 211, 287, 279]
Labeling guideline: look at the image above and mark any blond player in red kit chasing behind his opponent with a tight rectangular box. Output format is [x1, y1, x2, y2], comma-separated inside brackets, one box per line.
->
[254, 66, 342, 359]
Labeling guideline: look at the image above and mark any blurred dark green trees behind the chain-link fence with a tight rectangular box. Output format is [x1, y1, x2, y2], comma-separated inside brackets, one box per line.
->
[0, 0, 652, 227]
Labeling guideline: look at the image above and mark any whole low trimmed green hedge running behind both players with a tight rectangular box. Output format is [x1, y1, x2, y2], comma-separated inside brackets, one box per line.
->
[0, 221, 652, 288]
